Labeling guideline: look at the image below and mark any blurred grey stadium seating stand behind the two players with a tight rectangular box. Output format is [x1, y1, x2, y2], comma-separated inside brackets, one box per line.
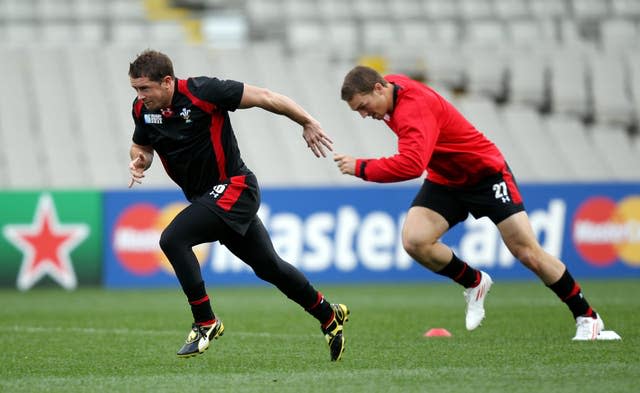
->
[0, 0, 640, 189]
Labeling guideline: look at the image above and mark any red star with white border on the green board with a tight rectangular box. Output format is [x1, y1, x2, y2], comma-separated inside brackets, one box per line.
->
[4, 194, 89, 291]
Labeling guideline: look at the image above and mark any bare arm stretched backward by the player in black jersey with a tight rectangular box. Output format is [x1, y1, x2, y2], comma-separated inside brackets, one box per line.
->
[240, 84, 333, 157]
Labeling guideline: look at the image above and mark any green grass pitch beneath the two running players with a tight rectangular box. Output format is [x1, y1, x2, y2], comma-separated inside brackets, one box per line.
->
[0, 279, 640, 393]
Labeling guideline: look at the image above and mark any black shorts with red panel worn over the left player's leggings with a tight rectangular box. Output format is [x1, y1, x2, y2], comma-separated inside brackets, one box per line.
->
[192, 173, 260, 236]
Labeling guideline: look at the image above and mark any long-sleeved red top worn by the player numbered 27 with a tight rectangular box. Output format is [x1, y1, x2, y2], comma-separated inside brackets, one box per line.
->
[356, 75, 506, 187]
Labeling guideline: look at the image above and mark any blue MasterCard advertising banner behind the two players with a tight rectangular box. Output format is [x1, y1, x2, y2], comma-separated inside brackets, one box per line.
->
[103, 183, 640, 287]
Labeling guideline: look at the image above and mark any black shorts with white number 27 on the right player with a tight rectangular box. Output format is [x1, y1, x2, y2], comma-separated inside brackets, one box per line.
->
[411, 166, 524, 228]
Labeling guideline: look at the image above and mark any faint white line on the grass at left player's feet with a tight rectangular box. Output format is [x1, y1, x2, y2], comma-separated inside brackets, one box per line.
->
[0, 325, 316, 338]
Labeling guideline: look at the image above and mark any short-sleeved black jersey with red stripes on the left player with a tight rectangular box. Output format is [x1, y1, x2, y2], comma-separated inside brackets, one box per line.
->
[133, 77, 251, 201]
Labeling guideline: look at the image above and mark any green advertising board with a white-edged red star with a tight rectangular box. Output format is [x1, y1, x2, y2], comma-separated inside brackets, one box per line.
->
[0, 191, 103, 290]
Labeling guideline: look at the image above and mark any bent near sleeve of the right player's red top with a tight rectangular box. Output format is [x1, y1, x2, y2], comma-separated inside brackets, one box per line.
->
[355, 107, 439, 183]
